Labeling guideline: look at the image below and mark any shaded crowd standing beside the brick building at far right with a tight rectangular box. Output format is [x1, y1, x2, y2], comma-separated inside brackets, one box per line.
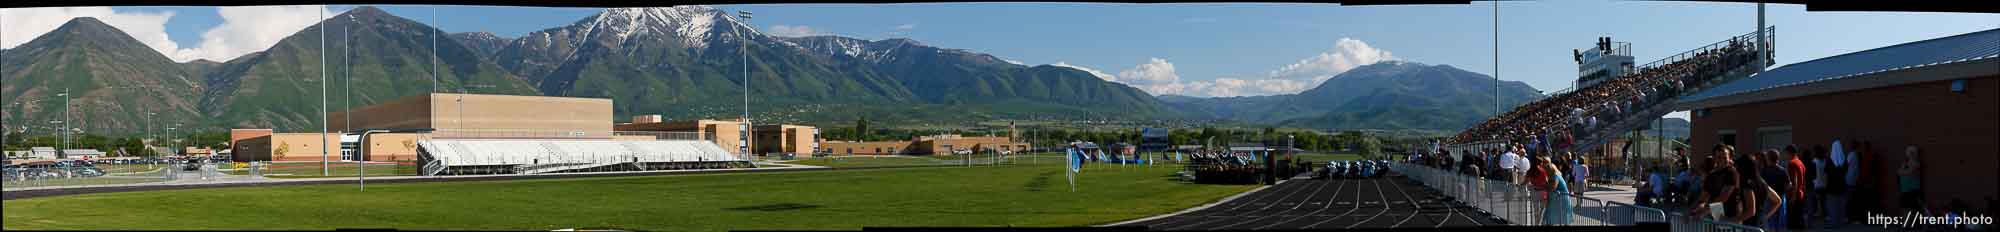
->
[1636, 138, 1992, 230]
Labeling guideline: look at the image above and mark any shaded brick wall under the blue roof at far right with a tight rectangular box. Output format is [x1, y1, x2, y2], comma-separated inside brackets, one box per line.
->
[1690, 76, 2000, 212]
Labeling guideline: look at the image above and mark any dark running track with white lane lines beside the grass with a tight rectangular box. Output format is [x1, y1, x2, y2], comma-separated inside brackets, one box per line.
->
[1118, 176, 1500, 230]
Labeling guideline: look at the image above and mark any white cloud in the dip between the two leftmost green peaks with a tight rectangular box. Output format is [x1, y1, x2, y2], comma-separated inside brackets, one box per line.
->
[168, 6, 340, 62]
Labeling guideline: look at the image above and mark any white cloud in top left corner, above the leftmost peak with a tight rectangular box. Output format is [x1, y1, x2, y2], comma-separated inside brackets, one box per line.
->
[0, 6, 180, 54]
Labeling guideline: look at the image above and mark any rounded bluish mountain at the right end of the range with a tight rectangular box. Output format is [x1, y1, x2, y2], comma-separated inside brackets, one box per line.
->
[1160, 60, 1542, 130]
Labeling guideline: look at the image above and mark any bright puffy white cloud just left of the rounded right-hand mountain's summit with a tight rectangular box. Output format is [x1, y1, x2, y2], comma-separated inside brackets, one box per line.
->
[1270, 38, 1396, 86]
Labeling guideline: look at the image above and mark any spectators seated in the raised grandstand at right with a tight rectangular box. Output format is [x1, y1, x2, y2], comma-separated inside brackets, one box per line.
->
[1450, 38, 1758, 148]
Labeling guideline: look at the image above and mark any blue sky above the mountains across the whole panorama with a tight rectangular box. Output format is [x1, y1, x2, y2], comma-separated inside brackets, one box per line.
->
[0, 0, 2000, 104]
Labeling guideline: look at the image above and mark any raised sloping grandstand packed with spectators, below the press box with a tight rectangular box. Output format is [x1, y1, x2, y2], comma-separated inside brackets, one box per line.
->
[1450, 28, 1776, 152]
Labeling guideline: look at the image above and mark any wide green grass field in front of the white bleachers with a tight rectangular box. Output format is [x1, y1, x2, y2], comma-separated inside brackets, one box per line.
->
[4, 162, 1254, 230]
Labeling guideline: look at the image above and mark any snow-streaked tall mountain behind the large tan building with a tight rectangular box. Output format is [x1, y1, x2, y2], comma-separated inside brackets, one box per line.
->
[492, 6, 1166, 121]
